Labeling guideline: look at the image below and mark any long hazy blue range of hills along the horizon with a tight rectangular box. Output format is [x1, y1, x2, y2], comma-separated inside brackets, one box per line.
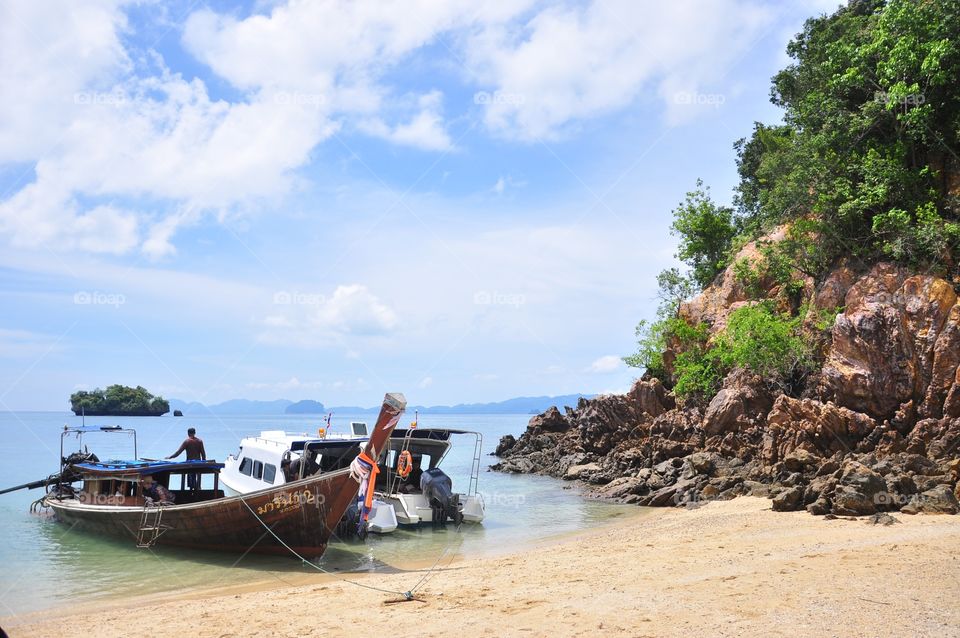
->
[171, 394, 596, 416]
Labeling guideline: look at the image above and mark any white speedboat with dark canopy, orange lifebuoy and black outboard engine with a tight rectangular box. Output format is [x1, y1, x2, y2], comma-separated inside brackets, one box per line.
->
[377, 428, 484, 525]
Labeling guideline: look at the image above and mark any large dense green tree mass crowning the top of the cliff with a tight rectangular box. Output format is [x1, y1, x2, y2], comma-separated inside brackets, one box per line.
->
[735, 0, 960, 271]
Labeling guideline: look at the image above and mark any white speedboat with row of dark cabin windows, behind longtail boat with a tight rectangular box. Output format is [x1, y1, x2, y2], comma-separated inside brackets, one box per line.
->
[220, 421, 397, 534]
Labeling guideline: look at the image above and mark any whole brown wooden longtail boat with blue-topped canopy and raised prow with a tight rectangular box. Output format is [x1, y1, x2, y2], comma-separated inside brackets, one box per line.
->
[41, 394, 406, 558]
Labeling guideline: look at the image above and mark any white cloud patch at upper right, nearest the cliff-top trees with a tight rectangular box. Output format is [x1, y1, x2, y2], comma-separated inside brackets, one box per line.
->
[467, 0, 772, 140]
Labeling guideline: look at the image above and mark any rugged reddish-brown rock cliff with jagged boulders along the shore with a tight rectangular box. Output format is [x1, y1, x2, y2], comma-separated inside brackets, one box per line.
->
[493, 258, 960, 515]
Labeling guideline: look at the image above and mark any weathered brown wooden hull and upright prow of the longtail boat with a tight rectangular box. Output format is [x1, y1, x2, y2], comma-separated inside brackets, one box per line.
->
[46, 395, 404, 558]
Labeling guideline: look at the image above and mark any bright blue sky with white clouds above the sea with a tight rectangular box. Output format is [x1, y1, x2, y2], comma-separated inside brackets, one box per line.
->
[0, 0, 838, 410]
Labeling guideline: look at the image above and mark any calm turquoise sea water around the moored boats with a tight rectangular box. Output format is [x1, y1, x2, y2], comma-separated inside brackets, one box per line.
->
[0, 412, 636, 617]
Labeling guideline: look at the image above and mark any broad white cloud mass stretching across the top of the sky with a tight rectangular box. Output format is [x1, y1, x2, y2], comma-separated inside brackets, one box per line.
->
[0, 0, 770, 259]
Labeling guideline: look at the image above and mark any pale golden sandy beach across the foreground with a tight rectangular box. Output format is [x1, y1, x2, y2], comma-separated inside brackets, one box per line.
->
[0, 497, 960, 638]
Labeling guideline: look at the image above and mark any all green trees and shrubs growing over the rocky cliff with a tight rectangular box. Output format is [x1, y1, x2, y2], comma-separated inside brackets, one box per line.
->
[624, 0, 960, 398]
